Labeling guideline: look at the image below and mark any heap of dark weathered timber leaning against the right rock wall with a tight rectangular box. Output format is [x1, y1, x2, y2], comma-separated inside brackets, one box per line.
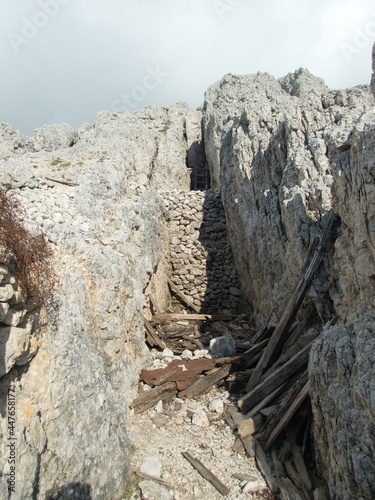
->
[226, 212, 335, 500]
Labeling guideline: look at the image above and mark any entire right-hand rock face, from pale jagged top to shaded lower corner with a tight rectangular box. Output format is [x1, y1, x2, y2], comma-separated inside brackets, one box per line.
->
[204, 70, 375, 498]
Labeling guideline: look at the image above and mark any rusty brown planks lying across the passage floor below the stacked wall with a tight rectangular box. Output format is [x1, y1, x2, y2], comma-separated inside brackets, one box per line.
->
[132, 313, 249, 412]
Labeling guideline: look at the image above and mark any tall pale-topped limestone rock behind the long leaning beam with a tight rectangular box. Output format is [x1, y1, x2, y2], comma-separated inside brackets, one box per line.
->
[204, 73, 373, 318]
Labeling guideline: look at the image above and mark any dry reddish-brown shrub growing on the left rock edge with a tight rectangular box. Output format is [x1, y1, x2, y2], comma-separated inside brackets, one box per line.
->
[0, 187, 56, 310]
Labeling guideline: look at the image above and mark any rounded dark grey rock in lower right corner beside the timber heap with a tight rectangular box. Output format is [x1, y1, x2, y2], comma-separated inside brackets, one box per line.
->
[310, 313, 375, 498]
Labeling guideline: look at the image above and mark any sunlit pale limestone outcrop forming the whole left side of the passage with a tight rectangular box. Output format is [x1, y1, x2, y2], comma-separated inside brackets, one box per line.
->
[0, 100, 203, 499]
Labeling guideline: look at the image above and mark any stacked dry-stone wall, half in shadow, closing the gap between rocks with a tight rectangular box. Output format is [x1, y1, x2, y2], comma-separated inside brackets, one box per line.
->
[160, 190, 240, 312]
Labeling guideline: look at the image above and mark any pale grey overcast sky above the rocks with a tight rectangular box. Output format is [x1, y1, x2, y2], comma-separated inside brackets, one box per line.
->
[0, 0, 375, 135]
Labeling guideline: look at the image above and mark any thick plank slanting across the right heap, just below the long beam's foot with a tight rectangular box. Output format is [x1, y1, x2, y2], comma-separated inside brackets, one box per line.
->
[238, 342, 312, 412]
